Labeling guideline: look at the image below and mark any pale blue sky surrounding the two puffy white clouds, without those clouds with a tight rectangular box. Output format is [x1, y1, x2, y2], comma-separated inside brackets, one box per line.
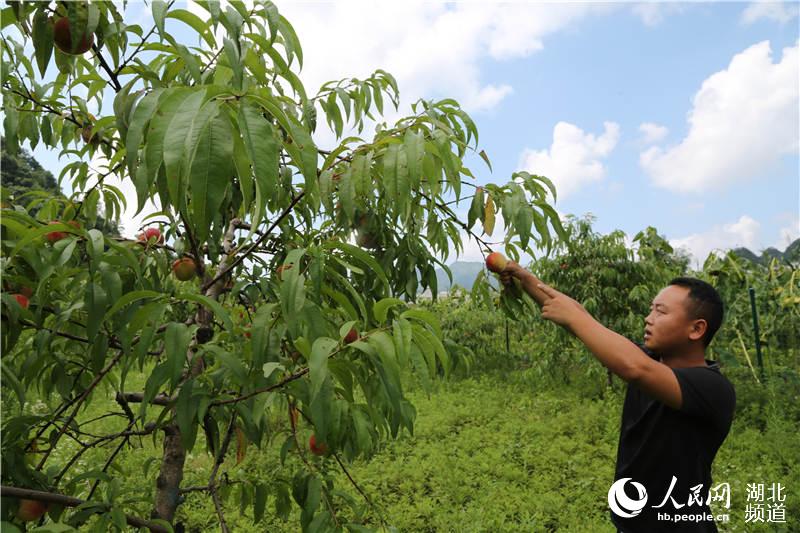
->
[462, 3, 800, 264]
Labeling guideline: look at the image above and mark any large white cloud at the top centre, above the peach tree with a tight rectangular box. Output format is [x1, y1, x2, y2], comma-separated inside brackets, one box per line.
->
[278, 2, 610, 119]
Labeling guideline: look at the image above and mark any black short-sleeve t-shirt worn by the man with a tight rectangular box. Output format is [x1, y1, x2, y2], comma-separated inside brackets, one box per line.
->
[609, 346, 736, 533]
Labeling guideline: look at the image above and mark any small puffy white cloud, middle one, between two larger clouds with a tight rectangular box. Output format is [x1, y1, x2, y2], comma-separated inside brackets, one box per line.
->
[519, 122, 619, 199]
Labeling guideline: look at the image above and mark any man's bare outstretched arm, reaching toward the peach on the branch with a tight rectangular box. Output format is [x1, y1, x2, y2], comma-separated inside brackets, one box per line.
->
[500, 261, 682, 409]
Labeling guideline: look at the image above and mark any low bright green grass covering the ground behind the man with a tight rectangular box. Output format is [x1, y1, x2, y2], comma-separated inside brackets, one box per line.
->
[9, 356, 800, 533]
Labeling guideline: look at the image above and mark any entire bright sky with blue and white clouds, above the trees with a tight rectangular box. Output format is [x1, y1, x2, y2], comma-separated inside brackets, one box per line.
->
[12, 2, 800, 261]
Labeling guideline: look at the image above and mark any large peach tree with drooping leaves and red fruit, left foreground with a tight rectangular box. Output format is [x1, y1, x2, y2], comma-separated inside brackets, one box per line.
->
[0, 0, 561, 531]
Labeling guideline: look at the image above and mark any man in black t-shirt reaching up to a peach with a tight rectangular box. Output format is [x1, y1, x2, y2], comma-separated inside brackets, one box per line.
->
[500, 261, 736, 533]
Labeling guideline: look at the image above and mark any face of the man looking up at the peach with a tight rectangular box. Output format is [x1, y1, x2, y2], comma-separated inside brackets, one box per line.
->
[644, 285, 698, 353]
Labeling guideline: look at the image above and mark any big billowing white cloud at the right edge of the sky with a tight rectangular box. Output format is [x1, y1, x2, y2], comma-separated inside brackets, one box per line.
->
[639, 41, 800, 192]
